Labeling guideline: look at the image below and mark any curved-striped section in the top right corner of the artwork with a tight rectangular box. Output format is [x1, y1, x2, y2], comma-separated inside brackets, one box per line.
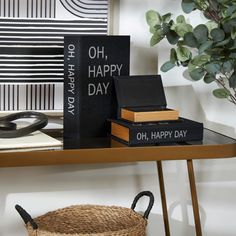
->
[60, 0, 108, 18]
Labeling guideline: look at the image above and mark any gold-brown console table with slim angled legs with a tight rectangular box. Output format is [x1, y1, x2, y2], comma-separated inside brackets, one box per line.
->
[0, 129, 236, 236]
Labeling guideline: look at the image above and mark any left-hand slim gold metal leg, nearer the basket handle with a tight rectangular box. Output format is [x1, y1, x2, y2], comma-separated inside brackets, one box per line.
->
[157, 161, 170, 236]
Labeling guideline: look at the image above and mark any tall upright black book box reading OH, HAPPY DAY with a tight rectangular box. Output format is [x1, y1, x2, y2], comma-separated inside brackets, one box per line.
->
[64, 35, 130, 149]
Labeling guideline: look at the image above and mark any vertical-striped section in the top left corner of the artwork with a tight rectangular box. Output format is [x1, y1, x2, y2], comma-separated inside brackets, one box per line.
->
[0, 0, 58, 18]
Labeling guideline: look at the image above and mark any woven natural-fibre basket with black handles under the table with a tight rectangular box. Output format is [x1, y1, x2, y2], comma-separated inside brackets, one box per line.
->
[15, 191, 154, 236]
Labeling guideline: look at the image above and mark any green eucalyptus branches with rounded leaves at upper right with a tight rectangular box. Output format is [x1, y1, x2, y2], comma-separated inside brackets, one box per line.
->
[146, 0, 236, 105]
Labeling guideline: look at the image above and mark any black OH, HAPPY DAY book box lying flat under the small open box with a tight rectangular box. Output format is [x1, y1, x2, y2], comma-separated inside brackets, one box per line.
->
[111, 117, 203, 146]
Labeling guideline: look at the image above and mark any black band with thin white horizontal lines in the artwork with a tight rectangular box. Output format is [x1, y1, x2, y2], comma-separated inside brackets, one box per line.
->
[0, 45, 64, 83]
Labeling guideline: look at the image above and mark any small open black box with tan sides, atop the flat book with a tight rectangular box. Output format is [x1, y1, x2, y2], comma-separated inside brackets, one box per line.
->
[114, 75, 179, 122]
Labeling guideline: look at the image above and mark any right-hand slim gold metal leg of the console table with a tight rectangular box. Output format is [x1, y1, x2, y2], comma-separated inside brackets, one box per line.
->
[187, 160, 202, 236]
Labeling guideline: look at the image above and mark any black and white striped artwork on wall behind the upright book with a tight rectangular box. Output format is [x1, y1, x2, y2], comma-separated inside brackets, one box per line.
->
[0, 0, 112, 112]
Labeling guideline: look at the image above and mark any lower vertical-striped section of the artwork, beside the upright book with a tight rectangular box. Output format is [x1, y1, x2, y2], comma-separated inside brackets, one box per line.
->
[0, 83, 63, 111]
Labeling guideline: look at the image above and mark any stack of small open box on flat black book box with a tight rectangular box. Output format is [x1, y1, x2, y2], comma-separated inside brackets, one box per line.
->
[111, 75, 203, 146]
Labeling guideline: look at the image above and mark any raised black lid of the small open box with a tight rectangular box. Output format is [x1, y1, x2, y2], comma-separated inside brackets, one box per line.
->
[114, 75, 167, 109]
